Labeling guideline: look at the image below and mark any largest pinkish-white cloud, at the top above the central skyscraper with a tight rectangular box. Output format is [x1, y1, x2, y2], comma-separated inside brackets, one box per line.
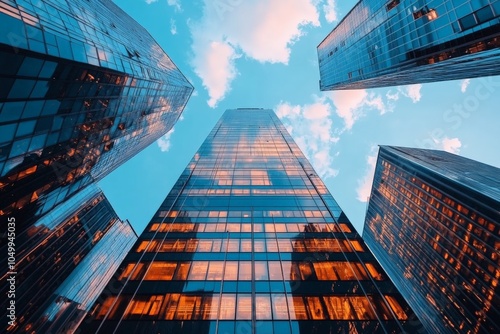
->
[189, 0, 319, 107]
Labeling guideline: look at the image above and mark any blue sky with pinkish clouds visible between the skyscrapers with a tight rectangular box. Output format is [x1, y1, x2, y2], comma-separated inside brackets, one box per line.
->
[99, 0, 500, 233]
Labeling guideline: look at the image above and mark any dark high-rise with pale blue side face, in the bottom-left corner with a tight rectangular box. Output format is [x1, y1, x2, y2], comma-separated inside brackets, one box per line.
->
[0, 185, 137, 333]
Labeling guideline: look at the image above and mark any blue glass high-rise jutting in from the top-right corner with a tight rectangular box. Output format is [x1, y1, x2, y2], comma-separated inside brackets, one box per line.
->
[318, 0, 500, 90]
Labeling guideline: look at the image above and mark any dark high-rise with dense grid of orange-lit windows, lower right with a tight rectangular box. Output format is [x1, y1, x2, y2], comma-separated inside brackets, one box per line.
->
[363, 146, 500, 333]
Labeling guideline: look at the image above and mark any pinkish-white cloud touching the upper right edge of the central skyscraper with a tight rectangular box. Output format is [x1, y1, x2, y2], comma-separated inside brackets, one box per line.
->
[275, 98, 339, 179]
